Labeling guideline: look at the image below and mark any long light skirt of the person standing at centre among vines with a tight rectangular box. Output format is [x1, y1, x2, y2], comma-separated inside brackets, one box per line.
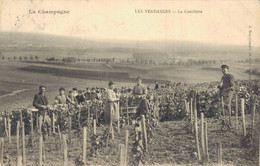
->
[104, 102, 119, 125]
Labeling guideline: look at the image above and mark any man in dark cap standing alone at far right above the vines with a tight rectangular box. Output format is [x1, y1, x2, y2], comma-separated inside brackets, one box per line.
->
[218, 65, 235, 118]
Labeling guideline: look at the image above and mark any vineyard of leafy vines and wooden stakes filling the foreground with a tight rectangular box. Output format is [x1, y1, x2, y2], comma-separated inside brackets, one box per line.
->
[0, 80, 260, 166]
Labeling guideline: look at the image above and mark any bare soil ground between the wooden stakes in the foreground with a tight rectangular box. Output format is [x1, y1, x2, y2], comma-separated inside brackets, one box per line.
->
[1, 117, 258, 166]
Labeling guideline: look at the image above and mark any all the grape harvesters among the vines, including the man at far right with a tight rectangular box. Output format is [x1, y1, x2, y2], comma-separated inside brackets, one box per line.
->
[33, 65, 235, 124]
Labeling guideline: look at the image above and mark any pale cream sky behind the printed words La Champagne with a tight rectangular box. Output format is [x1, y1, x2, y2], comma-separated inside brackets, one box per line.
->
[0, 0, 260, 47]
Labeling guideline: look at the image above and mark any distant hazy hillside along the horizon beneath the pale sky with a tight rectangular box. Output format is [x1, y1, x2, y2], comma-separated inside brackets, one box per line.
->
[0, 32, 260, 60]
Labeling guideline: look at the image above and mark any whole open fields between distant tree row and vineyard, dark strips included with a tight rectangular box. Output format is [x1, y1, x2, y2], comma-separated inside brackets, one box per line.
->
[0, 61, 259, 110]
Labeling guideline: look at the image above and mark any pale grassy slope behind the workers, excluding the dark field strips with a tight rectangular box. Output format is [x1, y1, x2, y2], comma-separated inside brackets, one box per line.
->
[0, 62, 256, 110]
